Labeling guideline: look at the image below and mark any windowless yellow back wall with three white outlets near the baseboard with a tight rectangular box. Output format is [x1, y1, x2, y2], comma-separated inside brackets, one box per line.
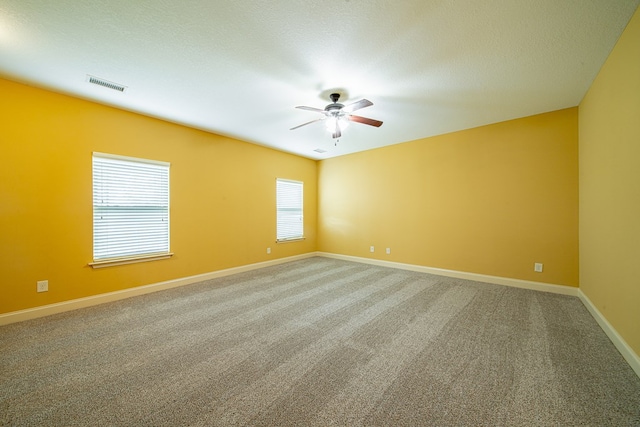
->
[318, 108, 578, 286]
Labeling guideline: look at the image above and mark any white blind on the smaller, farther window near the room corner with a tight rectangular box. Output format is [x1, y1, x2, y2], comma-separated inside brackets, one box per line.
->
[276, 179, 304, 241]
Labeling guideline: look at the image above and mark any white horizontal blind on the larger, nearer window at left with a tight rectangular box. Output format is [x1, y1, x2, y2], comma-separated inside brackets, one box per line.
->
[93, 153, 169, 261]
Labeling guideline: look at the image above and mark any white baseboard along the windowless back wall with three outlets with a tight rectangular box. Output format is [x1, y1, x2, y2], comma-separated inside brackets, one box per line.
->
[318, 252, 578, 296]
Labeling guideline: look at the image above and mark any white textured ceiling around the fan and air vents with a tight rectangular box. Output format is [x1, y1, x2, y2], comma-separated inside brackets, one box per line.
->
[0, 0, 640, 159]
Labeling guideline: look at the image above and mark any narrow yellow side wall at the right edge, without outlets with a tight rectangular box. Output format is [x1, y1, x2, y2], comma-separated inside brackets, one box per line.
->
[579, 9, 640, 354]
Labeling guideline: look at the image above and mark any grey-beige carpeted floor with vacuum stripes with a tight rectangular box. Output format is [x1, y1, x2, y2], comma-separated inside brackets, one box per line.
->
[0, 258, 640, 426]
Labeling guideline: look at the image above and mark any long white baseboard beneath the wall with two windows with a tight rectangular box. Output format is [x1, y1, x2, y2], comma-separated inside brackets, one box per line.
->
[0, 252, 316, 326]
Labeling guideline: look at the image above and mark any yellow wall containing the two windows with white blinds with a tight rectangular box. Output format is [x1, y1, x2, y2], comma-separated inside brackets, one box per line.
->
[0, 79, 317, 313]
